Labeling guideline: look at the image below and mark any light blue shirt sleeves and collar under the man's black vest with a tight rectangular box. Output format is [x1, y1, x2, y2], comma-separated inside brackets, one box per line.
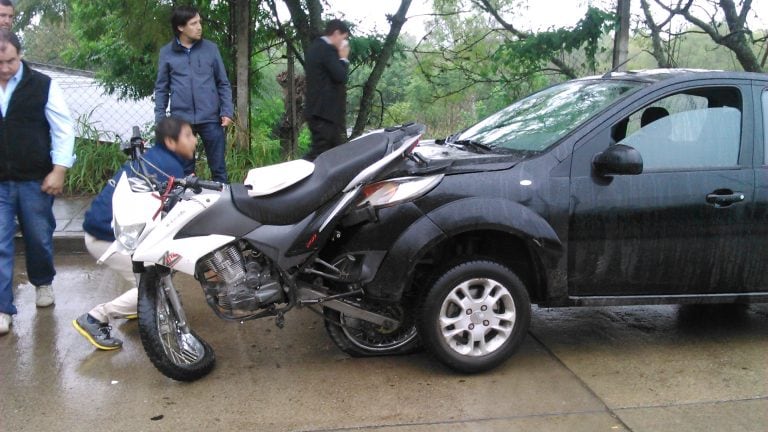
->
[0, 63, 75, 168]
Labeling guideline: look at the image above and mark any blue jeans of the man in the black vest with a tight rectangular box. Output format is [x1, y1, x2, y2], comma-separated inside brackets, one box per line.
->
[0, 180, 56, 315]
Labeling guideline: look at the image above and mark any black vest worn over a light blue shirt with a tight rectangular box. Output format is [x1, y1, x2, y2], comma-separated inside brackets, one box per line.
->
[0, 63, 53, 181]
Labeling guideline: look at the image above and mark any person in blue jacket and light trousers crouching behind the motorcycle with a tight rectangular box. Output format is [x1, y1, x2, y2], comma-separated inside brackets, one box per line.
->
[72, 117, 197, 350]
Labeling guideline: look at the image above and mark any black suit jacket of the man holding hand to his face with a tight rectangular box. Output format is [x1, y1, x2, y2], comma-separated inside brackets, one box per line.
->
[304, 38, 349, 125]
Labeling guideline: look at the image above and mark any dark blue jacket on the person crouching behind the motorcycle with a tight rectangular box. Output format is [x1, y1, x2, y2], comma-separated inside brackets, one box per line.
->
[83, 144, 184, 242]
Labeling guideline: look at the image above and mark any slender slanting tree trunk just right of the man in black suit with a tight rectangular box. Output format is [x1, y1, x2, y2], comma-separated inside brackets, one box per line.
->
[351, 0, 411, 138]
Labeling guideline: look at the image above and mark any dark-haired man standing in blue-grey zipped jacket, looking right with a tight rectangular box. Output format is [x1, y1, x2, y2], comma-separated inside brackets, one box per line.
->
[155, 6, 234, 183]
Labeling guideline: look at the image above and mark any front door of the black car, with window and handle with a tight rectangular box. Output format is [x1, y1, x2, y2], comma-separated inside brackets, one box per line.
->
[568, 81, 754, 296]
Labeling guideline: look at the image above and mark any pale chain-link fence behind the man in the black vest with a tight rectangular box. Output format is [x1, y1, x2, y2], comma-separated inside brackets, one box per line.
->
[29, 62, 155, 142]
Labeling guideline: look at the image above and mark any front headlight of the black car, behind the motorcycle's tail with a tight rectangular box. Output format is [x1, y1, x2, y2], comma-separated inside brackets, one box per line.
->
[357, 174, 443, 207]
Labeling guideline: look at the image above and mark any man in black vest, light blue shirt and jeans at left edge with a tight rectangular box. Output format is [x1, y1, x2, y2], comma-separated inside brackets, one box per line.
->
[0, 28, 75, 335]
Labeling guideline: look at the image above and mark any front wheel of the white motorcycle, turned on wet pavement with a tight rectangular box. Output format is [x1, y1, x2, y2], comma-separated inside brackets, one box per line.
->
[138, 266, 216, 381]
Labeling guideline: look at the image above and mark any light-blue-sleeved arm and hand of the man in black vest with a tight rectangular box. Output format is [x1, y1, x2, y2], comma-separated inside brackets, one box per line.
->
[40, 81, 76, 195]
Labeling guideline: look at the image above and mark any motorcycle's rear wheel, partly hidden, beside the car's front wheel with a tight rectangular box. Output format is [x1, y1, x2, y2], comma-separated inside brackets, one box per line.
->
[323, 302, 421, 357]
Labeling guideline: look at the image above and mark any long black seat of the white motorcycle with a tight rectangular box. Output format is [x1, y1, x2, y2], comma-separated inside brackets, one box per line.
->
[230, 132, 390, 225]
